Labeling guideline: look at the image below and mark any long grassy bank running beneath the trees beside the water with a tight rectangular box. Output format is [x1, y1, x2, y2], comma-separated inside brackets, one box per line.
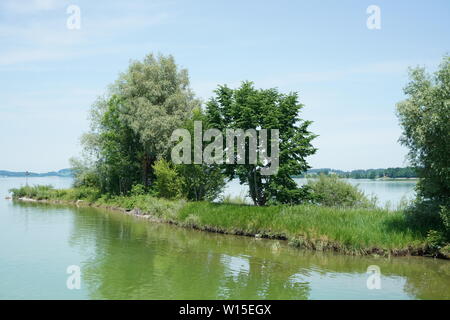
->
[7, 186, 440, 255]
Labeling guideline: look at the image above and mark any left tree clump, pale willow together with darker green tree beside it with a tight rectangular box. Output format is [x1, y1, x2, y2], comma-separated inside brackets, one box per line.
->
[73, 54, 199, 194]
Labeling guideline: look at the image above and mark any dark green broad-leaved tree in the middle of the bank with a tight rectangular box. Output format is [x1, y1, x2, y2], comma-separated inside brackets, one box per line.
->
[206, 82, 316, 205]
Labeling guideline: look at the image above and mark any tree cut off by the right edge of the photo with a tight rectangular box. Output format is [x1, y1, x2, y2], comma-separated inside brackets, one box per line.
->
[397, 56, 450, 245]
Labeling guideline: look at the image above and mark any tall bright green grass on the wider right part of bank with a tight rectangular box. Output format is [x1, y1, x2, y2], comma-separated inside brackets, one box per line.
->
[179, 203, 424, 252]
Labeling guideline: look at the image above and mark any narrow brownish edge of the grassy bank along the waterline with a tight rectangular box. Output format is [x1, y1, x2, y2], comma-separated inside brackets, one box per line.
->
[13, 197, 450, 259]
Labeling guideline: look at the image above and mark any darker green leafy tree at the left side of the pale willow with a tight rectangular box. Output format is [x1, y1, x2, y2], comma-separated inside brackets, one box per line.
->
[72, 95, 143, 194]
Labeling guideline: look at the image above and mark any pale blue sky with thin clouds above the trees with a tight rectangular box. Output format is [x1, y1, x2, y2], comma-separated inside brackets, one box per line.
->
[0, 0, 450, 172]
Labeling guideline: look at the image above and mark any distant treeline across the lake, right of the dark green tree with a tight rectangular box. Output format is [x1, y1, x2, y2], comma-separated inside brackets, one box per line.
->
[298, 167, 417, 179]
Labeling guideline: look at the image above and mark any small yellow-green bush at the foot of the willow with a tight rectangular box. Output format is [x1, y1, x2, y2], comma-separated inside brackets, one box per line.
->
[153, 159, 183, 199]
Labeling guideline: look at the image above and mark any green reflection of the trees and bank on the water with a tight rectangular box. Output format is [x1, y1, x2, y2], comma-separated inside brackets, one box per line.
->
[30, 204, 450, 299]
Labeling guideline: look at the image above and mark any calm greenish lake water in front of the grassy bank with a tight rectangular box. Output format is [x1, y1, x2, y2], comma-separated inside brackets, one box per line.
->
[0, 178, 450, 299]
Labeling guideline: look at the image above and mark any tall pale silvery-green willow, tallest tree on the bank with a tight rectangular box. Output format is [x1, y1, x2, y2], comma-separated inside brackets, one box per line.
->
[112, 54, 200, 186]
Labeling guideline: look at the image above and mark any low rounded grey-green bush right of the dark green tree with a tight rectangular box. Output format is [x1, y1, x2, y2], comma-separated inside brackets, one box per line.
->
[307, 174, 376, 208]
